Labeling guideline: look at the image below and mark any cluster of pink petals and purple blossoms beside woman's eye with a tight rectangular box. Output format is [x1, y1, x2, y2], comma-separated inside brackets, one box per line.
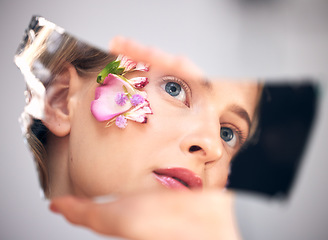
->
[91, 56, 152, 128]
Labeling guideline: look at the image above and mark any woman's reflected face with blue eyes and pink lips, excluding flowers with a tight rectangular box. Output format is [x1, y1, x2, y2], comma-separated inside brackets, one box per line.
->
[68, 67, 258, 197]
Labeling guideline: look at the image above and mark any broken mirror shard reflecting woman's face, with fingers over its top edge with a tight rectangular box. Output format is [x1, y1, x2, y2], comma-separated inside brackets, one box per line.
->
[15, 17, 316, 198]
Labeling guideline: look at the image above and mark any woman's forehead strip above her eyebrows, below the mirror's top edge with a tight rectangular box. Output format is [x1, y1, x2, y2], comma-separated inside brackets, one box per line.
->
[128, 68, 260, 120]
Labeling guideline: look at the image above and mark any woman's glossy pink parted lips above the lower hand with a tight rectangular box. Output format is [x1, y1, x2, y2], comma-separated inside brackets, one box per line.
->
[153, 168, 203, 189]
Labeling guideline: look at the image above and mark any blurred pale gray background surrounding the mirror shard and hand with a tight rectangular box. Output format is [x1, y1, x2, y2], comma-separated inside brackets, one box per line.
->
[0, 0, 328, 239]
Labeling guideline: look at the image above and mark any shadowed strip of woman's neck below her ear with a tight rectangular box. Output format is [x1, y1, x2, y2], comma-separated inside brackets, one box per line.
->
[46, 134, 72, 198]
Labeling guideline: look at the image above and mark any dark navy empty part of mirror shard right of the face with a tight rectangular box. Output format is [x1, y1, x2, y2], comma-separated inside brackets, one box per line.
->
[228, 78, 319, 199]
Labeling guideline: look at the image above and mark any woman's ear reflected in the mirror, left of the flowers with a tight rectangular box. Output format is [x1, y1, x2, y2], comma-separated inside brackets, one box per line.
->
[42, 65, 78, 137]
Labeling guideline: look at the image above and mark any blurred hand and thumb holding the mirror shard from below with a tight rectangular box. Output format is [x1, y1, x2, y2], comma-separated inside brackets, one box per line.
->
[50, 191, 240, 240]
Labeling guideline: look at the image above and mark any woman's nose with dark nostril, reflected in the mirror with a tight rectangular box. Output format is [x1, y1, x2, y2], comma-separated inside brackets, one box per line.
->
[180, 122, 223, 163]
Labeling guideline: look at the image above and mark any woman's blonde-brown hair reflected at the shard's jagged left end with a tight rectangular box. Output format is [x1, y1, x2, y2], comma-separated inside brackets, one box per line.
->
[15, 19, 116, 195]
